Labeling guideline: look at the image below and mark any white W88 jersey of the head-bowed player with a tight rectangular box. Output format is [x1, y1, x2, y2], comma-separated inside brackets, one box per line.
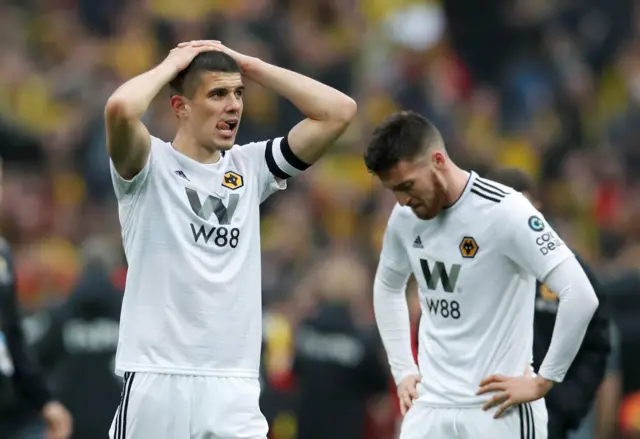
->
[380, 173, 573, 406]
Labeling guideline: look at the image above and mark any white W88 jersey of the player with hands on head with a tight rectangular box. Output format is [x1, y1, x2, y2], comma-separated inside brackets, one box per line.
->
[111, 137, 296, 377]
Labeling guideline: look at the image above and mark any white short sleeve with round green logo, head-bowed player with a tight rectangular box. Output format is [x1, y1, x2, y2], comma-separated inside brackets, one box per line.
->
[494, 193, 573, 281]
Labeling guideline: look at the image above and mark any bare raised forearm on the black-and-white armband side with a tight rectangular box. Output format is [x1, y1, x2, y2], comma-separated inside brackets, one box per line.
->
[244, 59, 356, 123]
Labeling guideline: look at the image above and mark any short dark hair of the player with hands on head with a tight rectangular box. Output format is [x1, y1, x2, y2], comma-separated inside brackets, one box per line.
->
[169, 50, 241, 97]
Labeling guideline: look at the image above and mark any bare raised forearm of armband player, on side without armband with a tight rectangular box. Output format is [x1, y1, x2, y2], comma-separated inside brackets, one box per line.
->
[106, 63, 177, 119]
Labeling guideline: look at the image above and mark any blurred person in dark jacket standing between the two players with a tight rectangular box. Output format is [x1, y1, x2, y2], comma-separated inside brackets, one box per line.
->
[293, 256, 389, 439]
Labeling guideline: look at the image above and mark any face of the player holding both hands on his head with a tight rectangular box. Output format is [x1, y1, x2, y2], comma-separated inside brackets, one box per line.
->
[176, 72, 244, 150]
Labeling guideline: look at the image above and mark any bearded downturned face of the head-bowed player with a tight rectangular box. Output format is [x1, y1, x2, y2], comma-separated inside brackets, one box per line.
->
[380, 157, 447, 220]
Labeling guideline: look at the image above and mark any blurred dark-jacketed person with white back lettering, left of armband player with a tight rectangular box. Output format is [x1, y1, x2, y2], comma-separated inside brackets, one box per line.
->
[28, 238, 123, 439]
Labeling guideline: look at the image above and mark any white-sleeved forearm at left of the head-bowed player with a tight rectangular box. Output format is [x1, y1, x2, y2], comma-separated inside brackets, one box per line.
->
[373, 270, 419, 384]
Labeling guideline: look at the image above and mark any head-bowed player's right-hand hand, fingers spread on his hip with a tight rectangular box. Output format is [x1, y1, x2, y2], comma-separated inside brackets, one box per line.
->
[477, 370, 553, 418]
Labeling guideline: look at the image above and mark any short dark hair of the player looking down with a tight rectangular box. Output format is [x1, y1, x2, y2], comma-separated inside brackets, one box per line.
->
[364, 111, 444, 175]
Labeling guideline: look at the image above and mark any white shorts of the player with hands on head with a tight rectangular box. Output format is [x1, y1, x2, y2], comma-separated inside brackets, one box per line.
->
[109, 372, 269, 439]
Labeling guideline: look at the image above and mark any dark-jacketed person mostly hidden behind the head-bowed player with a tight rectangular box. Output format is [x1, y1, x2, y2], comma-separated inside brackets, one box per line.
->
[486, 168, 610, 439]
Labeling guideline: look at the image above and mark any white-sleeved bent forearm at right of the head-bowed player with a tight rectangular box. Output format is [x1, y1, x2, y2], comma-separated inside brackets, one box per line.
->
[538, 258, 598, 382]
